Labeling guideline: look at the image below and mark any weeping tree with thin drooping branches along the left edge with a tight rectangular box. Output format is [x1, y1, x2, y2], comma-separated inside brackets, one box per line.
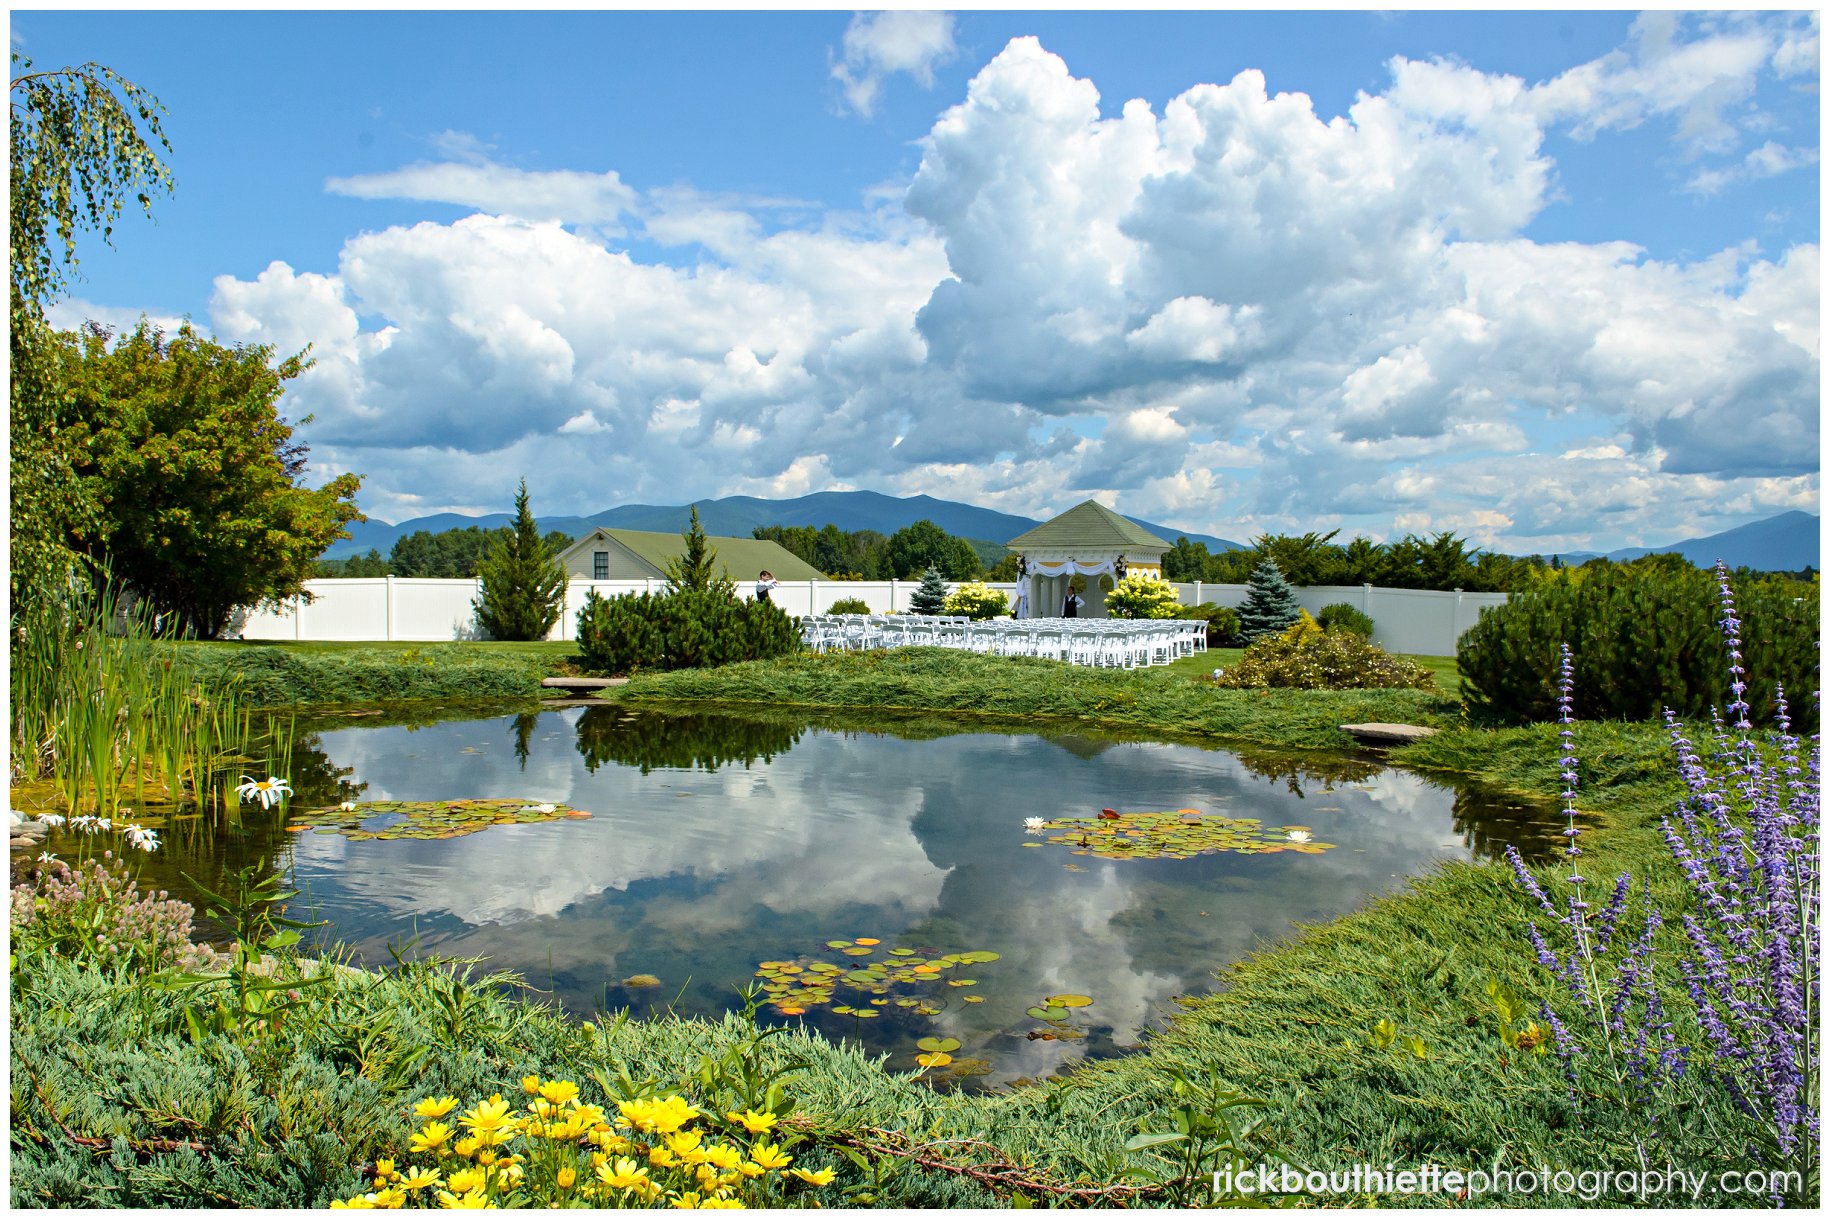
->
[7, 53, 172, 613]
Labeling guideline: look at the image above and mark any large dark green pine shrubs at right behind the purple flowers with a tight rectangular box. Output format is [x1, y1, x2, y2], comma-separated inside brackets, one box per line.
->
[1455, 566, 1821, 732]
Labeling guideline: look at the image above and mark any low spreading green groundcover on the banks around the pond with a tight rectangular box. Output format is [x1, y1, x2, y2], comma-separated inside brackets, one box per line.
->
[13, 644, 1737, 1206]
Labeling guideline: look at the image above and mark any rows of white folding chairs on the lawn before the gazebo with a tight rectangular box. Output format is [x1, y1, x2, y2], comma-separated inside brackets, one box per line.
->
[800, 613, 1208, 668]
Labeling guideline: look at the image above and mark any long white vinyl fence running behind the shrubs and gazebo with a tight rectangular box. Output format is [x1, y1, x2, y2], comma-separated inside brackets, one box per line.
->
[231, 577, 1506, 655]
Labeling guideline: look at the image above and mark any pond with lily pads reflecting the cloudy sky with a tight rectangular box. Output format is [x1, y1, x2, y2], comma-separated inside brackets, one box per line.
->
[39, 707, 1561, 1087]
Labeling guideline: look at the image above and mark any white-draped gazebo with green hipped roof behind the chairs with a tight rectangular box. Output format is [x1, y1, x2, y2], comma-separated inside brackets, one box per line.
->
[1005, 500, 1169, 619]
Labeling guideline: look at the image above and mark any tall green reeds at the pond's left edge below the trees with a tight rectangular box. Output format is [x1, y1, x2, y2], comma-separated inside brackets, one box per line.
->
[9, 584, 289, 816]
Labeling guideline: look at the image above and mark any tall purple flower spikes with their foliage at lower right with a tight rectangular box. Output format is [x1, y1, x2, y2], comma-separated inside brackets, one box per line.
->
[1508, 566, 1821, 1201]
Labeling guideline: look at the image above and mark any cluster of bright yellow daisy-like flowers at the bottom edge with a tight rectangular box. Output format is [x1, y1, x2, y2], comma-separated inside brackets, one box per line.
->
[331, 1074, 833, 1210]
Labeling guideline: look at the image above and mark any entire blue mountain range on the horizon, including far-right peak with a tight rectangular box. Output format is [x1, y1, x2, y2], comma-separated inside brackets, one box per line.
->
[324, 491, 1821, 571]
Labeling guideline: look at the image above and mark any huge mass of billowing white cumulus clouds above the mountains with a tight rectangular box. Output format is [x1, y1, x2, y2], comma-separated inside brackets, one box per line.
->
[212, 15, 1819, 549]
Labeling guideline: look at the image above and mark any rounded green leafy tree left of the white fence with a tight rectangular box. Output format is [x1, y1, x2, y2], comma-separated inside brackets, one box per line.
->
[59, 320, 362, 639]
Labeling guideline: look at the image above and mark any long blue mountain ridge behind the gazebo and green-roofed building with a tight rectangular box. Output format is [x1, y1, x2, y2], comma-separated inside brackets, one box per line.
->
[324, 491, 1241, 558]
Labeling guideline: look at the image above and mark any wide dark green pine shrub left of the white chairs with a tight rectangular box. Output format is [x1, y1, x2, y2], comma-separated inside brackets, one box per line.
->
[578, 588, 800, 674]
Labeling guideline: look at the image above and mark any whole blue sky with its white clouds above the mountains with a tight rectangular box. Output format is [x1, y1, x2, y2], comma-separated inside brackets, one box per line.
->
[11, 11, 1821, 551]
